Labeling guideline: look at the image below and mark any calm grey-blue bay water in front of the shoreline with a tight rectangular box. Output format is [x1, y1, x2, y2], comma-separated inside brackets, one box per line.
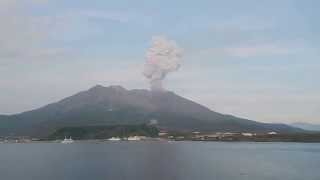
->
[0, 142, 320, 180]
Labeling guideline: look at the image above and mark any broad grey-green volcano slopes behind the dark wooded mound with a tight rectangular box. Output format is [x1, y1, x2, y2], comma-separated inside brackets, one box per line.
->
[0, 85, 303, 137]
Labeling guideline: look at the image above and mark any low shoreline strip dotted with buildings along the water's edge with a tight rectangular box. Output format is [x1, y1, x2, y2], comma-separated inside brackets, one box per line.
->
[0, 131, 320, 144]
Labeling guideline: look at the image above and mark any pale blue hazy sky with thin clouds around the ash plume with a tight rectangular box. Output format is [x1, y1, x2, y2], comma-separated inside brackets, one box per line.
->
[0, 0, 320, 123]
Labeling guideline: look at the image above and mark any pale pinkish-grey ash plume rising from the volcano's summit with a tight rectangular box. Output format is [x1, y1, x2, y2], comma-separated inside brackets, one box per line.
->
[143, 36, 182, 91]
